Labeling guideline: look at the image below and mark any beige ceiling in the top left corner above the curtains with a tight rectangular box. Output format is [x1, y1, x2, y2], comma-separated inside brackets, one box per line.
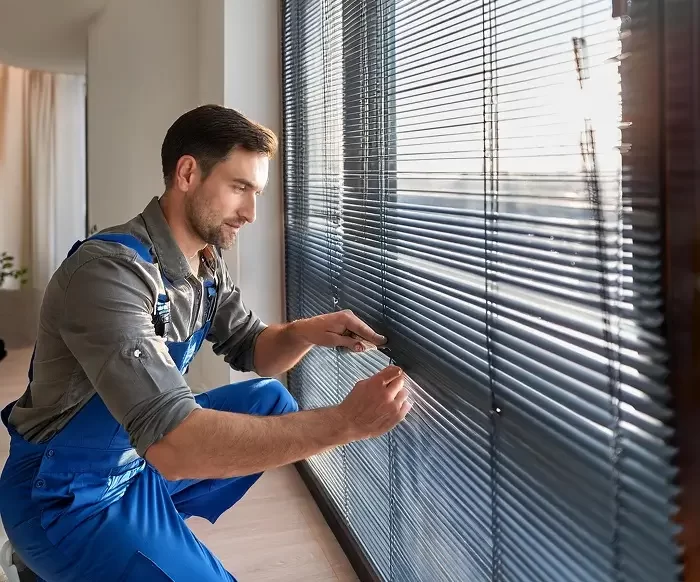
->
[0, 0, 108, 73]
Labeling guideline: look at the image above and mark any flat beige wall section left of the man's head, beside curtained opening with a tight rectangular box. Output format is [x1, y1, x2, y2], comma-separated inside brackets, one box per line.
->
[87, 0, 198, 229]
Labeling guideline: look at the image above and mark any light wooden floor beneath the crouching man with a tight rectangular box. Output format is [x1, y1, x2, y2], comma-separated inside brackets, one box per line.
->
[0, 350, 357, 582]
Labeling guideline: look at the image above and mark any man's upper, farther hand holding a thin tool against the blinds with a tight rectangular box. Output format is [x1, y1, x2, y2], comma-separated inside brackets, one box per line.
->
[293, 309, 386, 352]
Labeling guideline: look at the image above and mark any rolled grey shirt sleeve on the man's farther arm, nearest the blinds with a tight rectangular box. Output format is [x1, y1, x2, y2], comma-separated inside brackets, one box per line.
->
[207, 255, 267, 372]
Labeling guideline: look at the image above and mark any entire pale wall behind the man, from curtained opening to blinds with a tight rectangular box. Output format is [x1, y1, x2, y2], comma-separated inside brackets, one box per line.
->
[87, 0, 283, 390]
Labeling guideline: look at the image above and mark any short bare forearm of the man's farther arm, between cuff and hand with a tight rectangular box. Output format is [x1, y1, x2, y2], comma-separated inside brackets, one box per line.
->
[255, 323, 312, 376]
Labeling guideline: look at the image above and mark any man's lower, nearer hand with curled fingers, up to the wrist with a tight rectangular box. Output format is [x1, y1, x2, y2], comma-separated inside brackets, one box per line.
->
[337, 366, 411, 440]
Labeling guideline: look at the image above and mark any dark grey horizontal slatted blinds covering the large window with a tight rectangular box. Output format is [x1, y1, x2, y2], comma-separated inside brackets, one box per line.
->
[283, 0, 679, 582]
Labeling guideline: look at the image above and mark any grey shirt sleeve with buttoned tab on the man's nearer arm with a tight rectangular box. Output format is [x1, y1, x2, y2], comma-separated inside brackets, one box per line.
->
[60, 249, 199, 456]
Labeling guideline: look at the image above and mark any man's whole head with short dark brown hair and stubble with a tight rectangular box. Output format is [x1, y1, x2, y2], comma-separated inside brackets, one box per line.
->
[161, 105, 277, 249]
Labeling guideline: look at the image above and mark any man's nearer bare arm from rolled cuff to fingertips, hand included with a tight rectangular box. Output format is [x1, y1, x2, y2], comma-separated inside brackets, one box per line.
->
[146, 366, 411, 481]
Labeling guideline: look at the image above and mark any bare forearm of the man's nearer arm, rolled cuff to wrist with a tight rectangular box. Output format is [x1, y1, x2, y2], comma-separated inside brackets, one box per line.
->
[146, 408, 361, 480]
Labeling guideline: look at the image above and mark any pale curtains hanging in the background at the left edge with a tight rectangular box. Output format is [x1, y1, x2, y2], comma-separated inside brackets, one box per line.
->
[0, 64, 86, 290]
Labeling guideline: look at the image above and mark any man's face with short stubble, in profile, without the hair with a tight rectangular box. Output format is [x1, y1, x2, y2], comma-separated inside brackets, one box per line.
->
[181, 148, 269, 249]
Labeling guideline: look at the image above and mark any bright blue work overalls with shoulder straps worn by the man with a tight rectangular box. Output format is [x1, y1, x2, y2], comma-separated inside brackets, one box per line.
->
[0, 234, 297, 582]
